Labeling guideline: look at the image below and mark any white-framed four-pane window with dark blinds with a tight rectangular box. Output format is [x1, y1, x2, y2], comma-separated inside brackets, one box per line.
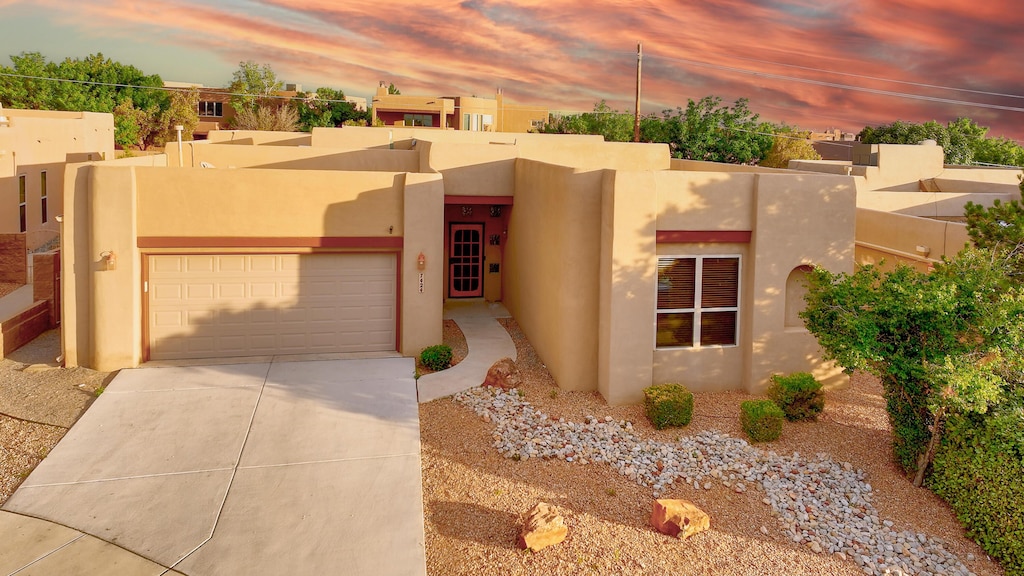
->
[655, 256, 739, 347]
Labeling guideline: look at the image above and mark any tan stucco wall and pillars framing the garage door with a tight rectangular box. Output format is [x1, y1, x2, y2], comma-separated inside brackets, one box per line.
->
[66, 165, 443, 370]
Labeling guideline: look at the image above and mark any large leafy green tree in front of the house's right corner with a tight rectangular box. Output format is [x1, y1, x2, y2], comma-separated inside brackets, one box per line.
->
[801, 196, 1024, 486]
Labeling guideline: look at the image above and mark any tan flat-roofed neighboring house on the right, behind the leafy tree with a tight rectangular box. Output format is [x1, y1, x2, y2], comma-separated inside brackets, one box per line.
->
[790, 142, 1021, 270]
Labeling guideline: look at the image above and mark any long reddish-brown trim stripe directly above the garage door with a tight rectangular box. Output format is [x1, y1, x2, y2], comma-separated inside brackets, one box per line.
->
[137, 236, 404, 249]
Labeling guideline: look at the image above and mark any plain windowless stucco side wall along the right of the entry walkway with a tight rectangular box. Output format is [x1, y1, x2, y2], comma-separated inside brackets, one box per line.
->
[503, 160, 603, 390]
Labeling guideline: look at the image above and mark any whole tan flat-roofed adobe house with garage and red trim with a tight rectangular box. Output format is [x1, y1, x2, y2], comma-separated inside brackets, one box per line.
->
[62, 127, 856, 404]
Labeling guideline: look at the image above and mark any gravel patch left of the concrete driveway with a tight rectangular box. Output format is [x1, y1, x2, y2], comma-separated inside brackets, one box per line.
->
[0, 330, 109, 504]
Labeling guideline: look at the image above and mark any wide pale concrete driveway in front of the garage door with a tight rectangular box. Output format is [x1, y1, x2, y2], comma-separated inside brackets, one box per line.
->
[3, 358, 426, 576]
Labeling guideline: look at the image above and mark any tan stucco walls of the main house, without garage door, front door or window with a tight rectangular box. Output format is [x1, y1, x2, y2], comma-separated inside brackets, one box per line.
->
[58, 121, 872, 404]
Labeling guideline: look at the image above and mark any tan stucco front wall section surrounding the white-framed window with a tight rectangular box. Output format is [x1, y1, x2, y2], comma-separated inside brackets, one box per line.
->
[598, 171, 855, 404]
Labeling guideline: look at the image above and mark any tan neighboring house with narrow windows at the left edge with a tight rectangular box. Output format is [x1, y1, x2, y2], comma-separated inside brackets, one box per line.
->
[0, 109, 114, 251]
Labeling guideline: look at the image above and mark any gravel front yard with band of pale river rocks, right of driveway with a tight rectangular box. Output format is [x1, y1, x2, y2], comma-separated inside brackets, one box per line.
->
[420, 320, 1002, 575]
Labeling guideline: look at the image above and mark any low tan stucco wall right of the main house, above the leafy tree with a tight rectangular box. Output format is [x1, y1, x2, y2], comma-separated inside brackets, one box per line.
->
[856, 208, 970, 272]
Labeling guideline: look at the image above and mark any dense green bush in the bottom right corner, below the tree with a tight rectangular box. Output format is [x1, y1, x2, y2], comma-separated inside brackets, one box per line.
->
[928, 407, 1024, 576]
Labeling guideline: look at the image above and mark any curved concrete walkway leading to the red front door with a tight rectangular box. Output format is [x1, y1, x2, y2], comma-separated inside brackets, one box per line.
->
[416, 300, 516, 403]
